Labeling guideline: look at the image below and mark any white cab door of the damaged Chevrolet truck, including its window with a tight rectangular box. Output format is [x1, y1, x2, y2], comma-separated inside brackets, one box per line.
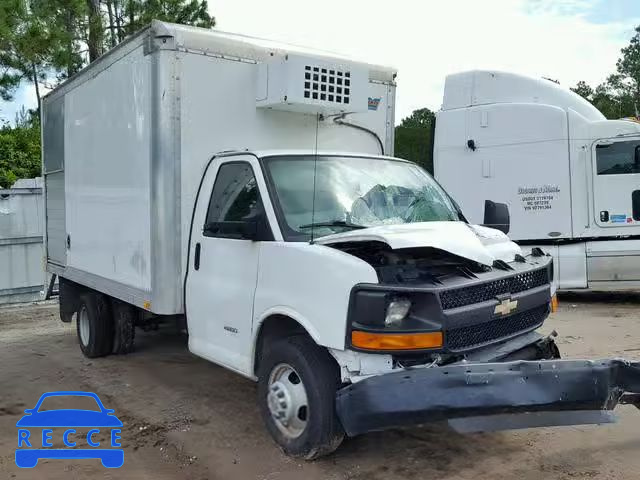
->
[185, 155, 273, 374]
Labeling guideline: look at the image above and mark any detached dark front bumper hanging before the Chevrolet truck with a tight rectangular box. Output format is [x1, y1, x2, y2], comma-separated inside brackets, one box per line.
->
[336, 359, 640, 436]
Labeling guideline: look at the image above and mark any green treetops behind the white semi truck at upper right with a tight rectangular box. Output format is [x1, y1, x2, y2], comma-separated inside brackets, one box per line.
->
[571, 26, 640, 119]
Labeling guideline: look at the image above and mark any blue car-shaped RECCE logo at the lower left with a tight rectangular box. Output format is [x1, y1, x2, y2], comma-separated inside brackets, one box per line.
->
[16, 392, 124, 468]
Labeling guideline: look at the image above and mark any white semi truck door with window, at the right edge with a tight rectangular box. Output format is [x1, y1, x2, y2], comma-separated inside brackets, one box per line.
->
[593, 138, 640, 228]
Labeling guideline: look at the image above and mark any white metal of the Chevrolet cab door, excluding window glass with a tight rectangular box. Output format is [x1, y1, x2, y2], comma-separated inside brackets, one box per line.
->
[185, 155, 270, 375]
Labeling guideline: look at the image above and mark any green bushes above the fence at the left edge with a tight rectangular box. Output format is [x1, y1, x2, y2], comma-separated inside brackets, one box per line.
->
[0, 109, 40, 188]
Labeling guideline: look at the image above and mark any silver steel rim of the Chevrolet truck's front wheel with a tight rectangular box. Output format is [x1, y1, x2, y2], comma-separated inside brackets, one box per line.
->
[267, 363, 309, 438]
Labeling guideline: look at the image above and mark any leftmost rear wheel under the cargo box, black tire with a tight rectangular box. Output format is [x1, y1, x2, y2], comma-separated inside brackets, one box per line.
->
[76, 292, 113, 358]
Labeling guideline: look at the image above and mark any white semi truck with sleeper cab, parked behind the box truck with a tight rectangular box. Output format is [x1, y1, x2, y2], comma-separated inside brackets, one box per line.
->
[434, 71, 640, 290]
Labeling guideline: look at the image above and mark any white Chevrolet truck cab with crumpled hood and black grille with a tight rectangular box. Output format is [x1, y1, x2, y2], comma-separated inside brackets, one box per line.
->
[185, 151, 553, 381]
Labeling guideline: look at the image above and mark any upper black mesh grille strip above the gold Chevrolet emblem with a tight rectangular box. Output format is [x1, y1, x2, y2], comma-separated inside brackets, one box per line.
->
[440, 267, 549, 310]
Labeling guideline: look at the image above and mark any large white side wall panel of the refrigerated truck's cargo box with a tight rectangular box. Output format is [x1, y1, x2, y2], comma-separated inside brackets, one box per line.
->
[65, 47, 151, 290]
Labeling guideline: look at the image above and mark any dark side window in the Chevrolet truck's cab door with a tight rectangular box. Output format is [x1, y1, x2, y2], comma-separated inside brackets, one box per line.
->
[204, 162, 264, 239]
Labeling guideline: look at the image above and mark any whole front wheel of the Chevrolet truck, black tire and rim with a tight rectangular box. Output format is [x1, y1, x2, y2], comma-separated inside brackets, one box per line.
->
[258, 336, 344, 460]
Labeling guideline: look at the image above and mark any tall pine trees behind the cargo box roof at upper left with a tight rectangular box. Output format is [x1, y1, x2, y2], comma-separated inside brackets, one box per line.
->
[0, 0, 215, 101]
